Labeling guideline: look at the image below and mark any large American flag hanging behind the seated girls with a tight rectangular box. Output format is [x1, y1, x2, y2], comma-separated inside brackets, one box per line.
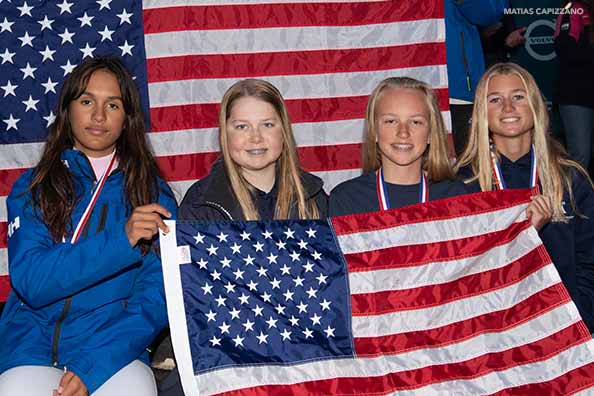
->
[0, 0, 449, 301]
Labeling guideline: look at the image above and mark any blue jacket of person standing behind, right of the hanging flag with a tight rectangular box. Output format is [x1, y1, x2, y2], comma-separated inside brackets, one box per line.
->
[445, 0, 509, 102]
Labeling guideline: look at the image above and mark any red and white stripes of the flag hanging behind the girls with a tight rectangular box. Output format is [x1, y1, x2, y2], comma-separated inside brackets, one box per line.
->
[0, 0, 450, 301]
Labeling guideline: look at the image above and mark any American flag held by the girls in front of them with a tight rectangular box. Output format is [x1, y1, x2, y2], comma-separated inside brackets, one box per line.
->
[161, 190, 594, 396]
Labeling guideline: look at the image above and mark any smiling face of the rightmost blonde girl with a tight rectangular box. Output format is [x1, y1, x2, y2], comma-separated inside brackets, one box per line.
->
[487, 74, 534, 147]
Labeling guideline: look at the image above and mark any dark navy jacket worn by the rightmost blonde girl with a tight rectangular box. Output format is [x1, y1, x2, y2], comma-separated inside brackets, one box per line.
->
[463, 153, 594, 332]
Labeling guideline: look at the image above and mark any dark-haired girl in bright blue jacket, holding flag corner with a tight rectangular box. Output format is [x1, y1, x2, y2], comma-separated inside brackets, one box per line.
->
[0, 58, 176, 396]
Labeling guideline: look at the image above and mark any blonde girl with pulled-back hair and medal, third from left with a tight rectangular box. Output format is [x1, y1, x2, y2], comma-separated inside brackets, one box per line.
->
[330, 77, 466, 216]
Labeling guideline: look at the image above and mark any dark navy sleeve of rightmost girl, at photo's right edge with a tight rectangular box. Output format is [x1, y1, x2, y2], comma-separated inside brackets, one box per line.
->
[573, 175, 594, 330]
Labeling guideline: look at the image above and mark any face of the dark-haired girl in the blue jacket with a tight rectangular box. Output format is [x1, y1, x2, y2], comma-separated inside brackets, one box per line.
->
[69, 70, 126, 157]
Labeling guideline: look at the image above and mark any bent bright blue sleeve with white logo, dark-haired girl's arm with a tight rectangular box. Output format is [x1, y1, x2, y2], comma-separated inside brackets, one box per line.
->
[7, 176, 142, 308]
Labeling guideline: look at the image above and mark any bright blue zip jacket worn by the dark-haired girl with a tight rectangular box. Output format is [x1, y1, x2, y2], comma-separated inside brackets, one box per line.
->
[0, 150, 176, 393]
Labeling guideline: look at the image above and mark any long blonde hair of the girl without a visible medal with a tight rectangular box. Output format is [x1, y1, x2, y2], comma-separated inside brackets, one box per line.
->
[219, 79, 319, 220]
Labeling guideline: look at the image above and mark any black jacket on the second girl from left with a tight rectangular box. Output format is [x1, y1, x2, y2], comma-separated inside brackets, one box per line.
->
[178, 160, 328, 221]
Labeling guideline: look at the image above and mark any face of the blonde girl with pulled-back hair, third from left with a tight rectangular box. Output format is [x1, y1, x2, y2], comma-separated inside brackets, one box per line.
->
[375, 87, 430, 181]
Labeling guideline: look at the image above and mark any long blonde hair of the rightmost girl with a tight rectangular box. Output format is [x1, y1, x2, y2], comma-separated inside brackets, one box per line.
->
[455, 63, 592, 222]
